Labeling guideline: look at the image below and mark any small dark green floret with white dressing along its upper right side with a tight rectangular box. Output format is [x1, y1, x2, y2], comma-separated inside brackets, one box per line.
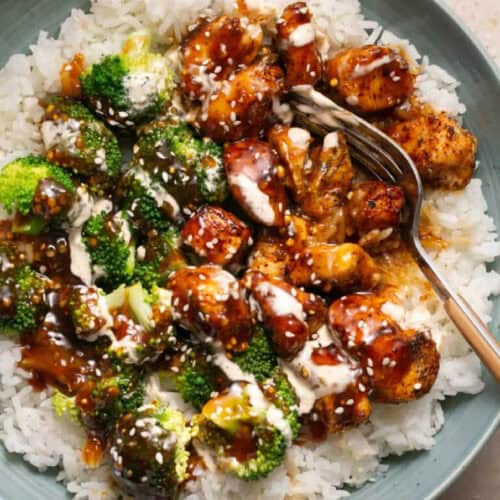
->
[116, 167, 179, 233]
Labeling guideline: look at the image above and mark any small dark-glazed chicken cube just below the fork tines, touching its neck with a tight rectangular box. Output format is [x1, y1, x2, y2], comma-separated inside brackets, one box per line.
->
[346, 181, 405, 250]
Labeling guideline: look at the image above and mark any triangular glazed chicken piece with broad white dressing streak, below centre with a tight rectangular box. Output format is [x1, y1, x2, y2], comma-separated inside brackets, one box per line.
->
[245, 273, 326, 358]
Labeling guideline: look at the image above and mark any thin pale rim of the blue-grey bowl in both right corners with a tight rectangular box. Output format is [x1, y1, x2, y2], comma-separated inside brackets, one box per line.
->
[425, 0, 500, 500]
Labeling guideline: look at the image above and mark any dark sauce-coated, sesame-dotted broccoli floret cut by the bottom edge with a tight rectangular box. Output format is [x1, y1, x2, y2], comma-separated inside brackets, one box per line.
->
[110, 403, 192, 498]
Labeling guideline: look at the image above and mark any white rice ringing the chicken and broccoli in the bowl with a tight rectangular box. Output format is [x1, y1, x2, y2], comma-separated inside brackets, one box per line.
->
[0, 0, 500, 500]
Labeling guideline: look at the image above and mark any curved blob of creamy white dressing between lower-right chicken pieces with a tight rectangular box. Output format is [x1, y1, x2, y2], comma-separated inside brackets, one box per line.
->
[289, 326, 360, 399]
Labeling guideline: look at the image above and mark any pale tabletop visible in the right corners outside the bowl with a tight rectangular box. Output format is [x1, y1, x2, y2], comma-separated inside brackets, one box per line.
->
[440, 0, 500, 500]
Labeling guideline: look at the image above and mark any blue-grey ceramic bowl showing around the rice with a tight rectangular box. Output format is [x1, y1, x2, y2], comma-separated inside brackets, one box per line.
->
[0, 0, 500, 500]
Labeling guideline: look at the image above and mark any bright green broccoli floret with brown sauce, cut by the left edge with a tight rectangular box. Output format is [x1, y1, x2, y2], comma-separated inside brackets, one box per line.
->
[0, 156, 75, 234]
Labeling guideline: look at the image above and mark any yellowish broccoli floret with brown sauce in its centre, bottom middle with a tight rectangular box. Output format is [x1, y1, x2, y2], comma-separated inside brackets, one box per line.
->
[197, 382, 292, 481]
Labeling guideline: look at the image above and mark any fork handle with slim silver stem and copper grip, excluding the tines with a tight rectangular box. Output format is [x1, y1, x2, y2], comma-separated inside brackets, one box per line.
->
[412, 244, 500, 382]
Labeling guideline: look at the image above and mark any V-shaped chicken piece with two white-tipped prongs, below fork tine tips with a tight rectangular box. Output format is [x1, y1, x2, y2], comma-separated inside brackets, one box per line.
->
[269, 125, 354, 219]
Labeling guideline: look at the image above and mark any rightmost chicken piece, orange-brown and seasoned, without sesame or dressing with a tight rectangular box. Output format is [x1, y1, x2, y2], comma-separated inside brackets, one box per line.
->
[386, 113, 477, 189]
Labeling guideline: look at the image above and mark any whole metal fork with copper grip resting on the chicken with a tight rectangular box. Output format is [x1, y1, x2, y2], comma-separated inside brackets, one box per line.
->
[290, 85, 500, 382]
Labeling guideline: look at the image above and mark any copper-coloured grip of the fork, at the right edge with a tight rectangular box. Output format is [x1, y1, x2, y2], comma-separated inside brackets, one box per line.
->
[444, 295, 500, 382]
